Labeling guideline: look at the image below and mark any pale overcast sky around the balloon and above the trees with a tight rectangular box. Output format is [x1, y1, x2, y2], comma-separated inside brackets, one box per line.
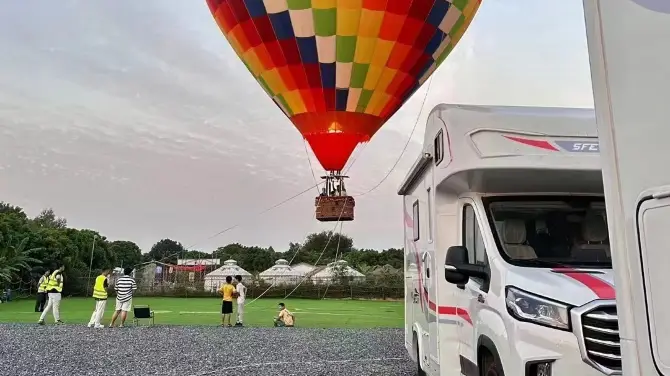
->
[0, 0, 592, 251]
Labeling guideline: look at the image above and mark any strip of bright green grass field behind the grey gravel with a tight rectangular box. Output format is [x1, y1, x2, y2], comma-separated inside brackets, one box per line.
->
[0, 297, 404, 328]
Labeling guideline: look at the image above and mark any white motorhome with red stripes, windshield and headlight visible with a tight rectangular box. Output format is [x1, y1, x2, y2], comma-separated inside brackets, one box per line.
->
[398, 104, 621, 376]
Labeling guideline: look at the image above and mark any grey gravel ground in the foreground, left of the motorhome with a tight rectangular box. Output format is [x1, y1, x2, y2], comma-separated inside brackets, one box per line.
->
[0, 324, 415, 376]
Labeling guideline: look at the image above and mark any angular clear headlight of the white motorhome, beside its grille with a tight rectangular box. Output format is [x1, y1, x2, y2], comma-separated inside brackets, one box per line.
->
[505, 287, 570, 330]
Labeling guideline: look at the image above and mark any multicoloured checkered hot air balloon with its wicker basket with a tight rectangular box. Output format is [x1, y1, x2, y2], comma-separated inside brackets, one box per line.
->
[207, 0, 481, 221]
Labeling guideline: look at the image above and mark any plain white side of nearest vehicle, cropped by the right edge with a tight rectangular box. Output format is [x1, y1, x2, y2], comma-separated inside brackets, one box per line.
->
[584, 0, 670, 376]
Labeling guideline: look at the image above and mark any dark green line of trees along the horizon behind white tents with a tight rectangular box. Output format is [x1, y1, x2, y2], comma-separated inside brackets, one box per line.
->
[0, 202, 404, 295]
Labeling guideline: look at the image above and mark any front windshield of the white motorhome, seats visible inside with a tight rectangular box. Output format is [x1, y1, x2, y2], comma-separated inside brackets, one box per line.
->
[484, 196, 612, 268]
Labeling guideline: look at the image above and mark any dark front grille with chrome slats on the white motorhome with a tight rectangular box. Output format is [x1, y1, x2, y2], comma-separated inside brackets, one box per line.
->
[582, 306, 621, 371]
